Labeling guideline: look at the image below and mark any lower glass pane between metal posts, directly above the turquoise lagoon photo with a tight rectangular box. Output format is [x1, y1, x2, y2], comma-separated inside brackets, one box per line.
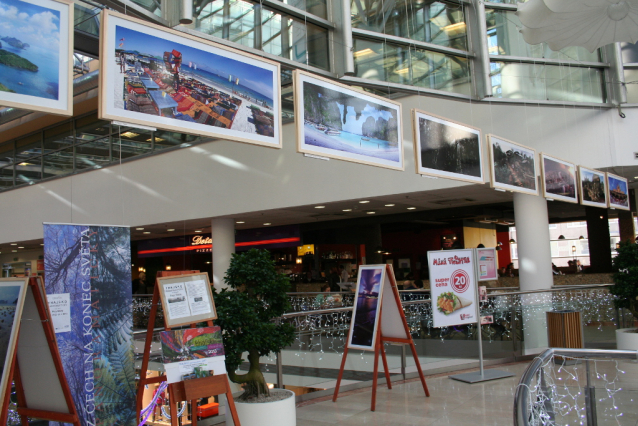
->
[354, 39, 471, 95]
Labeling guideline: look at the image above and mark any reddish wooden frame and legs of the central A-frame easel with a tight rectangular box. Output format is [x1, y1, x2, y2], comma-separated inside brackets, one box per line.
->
[332, 265, 430, 411]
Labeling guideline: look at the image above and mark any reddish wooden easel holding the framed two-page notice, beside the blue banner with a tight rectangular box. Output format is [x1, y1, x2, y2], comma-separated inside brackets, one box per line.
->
[136, 271, 240, 426]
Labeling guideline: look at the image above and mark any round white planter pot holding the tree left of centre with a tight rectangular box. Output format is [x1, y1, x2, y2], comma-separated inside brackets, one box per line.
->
[226, 389, 297, 426]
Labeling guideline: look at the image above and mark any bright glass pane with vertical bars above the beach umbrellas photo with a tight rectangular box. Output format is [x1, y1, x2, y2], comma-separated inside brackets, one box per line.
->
[195, 0, 329, 69]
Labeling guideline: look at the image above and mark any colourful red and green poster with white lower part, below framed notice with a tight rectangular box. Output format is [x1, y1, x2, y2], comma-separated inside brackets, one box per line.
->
[160, 327, 226, 383]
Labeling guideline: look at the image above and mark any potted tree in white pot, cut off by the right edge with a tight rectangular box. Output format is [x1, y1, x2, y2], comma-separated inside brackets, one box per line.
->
[609, 241, 638, 350]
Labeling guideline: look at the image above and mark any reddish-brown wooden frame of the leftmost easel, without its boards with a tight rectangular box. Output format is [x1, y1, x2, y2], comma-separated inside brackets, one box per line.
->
[0, 277, 80, 426]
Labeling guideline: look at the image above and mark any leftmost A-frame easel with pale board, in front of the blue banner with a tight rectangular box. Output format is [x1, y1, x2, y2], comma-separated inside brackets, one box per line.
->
[0, 277, 80, 426]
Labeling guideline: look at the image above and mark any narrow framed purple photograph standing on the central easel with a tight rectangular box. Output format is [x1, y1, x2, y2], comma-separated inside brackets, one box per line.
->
[348, 265, 386, 351]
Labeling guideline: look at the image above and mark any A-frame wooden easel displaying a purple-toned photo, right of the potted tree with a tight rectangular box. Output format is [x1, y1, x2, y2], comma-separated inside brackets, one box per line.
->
[332, 265, 430, 411]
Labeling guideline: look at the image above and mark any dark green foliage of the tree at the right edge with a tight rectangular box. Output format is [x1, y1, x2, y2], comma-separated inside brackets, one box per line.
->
[609, 241, 638, 319]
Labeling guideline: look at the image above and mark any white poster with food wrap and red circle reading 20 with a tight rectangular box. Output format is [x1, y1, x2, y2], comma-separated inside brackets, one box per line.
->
[428, 249, 478, 327]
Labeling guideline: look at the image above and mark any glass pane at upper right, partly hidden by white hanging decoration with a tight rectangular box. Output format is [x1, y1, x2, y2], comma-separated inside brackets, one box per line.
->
[485, 9, 600, 62]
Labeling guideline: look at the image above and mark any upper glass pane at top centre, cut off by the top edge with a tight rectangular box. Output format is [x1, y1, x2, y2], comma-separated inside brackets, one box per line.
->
[351, 0, 467, 50]
